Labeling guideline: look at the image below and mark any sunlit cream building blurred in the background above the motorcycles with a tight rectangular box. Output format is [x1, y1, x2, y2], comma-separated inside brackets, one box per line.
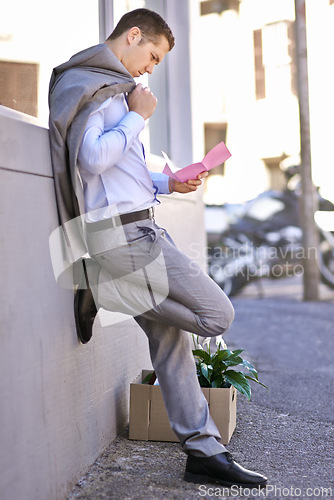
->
[194, 0, 334, 208]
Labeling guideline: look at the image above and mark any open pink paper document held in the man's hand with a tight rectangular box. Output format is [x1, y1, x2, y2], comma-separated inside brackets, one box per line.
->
[162, 142, 231, 182]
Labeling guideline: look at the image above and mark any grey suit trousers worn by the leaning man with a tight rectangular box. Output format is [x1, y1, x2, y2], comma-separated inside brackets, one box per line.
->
[88, 220, 234, 456]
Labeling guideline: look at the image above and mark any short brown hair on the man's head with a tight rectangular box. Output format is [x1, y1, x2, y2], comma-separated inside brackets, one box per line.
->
[108, 9, 175, 50]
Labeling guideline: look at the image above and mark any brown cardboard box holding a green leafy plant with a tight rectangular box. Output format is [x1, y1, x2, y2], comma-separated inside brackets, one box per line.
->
[129, 370, 237, 444]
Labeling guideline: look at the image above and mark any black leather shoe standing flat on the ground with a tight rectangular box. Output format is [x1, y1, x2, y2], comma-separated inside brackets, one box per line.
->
[184, 452, 267, 487]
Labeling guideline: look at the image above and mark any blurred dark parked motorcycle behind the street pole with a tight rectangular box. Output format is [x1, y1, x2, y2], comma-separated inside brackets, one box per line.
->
[208, 167, 334, 296]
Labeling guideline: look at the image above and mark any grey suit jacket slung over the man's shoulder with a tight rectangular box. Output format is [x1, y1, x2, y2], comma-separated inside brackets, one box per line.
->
[49, 44, 135, 288]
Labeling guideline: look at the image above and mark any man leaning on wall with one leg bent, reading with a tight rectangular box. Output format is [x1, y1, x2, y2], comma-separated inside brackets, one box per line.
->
[50, 5, 266, 486]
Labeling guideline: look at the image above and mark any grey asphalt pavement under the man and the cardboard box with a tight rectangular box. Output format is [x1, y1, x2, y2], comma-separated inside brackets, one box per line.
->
[68, 278, 334, 500]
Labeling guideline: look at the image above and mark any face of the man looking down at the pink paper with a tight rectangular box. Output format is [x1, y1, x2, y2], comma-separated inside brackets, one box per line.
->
[121, 35, 169, 77]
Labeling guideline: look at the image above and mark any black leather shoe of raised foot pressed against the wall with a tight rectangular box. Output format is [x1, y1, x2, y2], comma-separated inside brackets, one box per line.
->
[74, 261, 97, 344]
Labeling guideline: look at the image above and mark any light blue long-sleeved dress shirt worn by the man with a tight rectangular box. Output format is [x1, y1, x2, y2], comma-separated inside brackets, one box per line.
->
[78, 94, 169, 220]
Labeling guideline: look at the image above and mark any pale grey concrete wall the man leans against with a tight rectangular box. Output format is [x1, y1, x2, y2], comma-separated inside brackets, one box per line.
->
[0, 106, 204, 500]
